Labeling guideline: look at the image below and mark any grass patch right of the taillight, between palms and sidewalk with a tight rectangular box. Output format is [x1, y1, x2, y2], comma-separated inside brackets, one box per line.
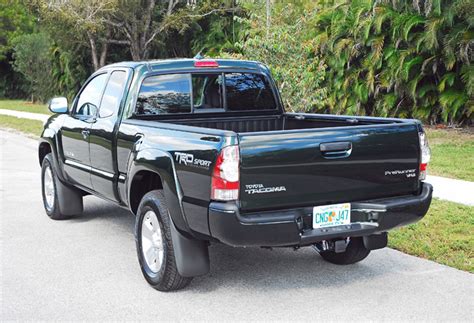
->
[426, 128, 474, 181]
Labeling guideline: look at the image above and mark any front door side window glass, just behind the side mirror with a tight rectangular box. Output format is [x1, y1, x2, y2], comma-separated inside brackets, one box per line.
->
[74, 73, 107, 116]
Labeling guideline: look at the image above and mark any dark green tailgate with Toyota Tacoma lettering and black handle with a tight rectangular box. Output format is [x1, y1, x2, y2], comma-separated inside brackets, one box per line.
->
[239, 123, 420, 210]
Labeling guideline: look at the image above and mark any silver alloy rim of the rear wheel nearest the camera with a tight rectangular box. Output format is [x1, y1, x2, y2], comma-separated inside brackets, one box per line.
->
[141, 211, 164, 274]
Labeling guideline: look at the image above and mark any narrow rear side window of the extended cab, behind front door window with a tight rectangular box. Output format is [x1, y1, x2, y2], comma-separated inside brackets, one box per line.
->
[99, 71, 127, 118]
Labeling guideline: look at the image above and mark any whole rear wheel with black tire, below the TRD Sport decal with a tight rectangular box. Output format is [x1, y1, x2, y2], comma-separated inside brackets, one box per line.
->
[135, 190, 192, 292]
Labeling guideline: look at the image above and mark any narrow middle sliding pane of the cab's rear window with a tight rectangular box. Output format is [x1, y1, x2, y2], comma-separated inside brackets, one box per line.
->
[192, 74, 224, 112]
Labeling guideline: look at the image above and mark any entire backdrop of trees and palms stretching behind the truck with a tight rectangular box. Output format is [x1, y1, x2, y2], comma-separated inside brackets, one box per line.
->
[0, 0, 474, 124]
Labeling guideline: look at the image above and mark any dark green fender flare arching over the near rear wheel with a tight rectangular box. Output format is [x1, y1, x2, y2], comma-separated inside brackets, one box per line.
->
[127, 148, 191, 233]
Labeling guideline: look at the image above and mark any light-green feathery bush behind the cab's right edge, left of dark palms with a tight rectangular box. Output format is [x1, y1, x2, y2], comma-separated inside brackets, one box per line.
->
[234, 2, 327, 111]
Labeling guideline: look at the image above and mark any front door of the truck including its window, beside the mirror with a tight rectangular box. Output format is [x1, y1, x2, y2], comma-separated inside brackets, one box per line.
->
[61, 73, 107, 188]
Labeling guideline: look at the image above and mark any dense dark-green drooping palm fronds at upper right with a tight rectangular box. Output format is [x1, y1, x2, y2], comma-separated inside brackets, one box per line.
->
[312, 0, 474, 124]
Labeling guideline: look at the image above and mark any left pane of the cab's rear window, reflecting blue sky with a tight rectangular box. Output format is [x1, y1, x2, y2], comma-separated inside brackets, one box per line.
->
[135, 74, 191, 115]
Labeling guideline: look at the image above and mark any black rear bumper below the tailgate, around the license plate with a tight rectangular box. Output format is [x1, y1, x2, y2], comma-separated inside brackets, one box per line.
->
[209, 183, 433, 247]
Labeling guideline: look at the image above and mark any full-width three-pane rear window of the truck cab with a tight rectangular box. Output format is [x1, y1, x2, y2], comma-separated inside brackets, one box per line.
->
[135, 73, 276, 115]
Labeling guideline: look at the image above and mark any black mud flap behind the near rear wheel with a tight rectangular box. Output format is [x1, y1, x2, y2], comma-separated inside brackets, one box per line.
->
[170, 221, 210, 277]
